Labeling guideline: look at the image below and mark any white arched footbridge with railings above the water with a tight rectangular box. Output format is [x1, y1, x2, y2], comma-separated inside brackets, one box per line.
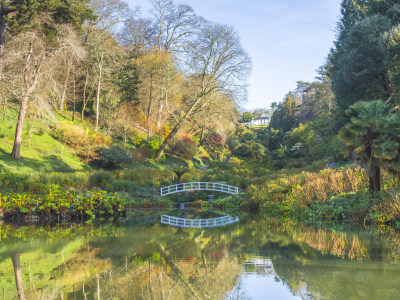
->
[160, 182, 239, 196]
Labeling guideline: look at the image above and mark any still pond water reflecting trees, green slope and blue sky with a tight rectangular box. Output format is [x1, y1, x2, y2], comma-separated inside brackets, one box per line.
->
[0, 213, 400, 300]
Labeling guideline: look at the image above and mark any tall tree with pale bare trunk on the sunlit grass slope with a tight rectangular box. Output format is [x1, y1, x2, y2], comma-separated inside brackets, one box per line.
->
[1, 0, 93, 160]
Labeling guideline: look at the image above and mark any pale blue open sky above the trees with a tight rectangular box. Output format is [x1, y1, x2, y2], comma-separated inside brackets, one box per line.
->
[127, 0, 341, 110]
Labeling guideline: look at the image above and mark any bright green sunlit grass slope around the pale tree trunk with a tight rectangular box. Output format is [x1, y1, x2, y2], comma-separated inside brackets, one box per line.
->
[0, 109, 88, 172]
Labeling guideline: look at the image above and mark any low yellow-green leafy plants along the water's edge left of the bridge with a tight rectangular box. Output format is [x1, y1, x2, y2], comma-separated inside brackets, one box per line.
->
[0, 187, 171, 221]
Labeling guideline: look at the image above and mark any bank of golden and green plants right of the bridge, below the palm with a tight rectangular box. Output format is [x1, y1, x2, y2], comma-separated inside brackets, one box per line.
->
[242, 166, 400, 228]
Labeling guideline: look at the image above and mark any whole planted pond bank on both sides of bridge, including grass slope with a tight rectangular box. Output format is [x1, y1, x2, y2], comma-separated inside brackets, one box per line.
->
[0, 104, 400, 228]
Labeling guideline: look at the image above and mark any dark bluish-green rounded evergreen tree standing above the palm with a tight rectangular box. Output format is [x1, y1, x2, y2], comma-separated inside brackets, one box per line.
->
[331, 15, 392, 111]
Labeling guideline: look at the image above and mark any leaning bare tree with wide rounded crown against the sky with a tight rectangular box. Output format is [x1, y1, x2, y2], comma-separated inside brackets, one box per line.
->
[156, 23, 251, 161]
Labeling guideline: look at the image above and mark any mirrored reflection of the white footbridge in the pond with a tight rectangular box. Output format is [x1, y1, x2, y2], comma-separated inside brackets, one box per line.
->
[161, 215, 239, 228]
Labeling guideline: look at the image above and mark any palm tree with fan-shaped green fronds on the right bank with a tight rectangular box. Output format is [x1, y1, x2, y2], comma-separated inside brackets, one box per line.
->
[339, 99, 400, 193]
